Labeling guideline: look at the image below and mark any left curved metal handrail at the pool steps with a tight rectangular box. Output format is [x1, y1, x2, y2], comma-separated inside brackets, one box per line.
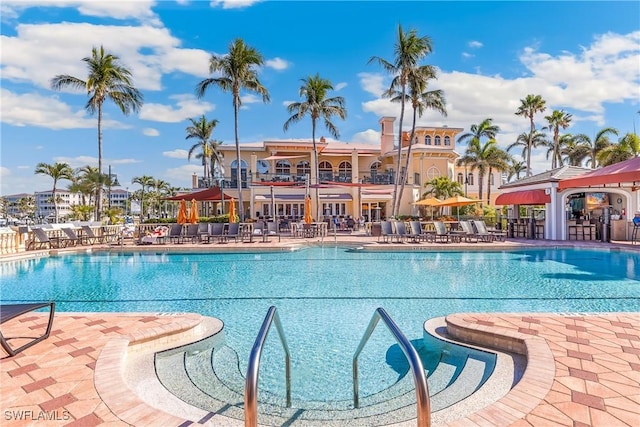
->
[244, 306, 291, 427]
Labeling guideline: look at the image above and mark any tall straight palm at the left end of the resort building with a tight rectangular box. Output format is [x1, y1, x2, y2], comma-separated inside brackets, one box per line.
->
[196, 39, 269, 221]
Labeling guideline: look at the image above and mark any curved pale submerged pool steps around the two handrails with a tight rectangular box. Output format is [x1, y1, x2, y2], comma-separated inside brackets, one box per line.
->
[156, 346, 496, 427]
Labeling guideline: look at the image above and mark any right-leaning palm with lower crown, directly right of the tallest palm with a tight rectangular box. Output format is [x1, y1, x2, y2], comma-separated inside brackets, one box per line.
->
[391, 65, 447, 214]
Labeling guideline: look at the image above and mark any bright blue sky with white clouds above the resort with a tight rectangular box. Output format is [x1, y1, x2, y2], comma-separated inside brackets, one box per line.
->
[0, 0, 640, 195]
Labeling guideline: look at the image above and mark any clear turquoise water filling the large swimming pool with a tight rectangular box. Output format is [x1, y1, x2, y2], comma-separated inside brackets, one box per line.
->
[0, 247, 640, 401]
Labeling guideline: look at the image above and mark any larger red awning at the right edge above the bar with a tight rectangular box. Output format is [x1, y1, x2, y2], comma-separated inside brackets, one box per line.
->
[558, 157, 640, 190]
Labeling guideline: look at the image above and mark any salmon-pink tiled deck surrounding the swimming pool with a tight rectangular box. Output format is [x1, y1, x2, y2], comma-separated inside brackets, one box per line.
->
[0, 236, 640, 427]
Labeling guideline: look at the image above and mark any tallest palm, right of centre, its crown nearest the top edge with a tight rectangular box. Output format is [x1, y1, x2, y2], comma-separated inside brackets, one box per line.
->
[369, 25, 433, 216]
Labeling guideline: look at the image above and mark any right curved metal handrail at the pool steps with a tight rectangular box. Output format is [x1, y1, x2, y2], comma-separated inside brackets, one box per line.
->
[353, 307, 431, 427]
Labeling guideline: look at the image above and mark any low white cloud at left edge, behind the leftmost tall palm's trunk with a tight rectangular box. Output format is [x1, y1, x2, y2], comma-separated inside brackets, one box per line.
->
[0, 89, 128, 130]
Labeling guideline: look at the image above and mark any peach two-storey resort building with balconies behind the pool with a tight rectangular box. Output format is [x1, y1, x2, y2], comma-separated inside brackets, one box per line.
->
[193, 117, 502, 221]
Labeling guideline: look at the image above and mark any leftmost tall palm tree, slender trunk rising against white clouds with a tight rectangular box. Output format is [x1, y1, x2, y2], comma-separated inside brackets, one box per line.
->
[51, 46, 143, 220]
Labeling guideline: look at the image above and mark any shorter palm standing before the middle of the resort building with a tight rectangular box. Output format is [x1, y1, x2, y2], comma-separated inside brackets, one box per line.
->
[282, 73, 347, 218]
